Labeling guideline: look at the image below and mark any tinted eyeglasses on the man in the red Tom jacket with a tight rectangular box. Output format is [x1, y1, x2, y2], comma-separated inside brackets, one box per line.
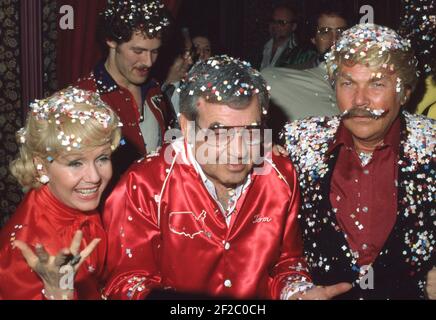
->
[195, 124, 265, 147]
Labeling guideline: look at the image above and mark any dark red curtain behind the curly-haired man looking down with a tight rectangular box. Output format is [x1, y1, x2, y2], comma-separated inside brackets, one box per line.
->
[57, 0, 181, 89]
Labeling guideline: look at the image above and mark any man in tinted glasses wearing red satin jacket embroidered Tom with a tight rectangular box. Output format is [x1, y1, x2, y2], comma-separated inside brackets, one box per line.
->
[103, 56, 351, 299]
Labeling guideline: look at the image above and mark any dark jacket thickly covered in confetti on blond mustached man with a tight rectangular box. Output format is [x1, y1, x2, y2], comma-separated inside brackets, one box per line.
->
[283, 112, 436, 299]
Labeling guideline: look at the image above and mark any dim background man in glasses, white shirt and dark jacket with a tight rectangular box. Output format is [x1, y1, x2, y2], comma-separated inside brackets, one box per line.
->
[260, 5, 297, 70]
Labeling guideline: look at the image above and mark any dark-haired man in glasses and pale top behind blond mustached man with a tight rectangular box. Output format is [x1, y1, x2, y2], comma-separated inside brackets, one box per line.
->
[262, 4, 348, 130]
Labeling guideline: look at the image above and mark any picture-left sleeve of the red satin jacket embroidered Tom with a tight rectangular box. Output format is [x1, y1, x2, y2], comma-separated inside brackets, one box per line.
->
[103, 162, 161, 300]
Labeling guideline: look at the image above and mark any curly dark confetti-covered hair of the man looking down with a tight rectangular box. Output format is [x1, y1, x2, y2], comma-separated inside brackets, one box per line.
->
[100, 0, 170, 44]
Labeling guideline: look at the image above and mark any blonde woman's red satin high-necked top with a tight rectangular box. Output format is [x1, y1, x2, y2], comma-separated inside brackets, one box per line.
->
[0, 186, 107, 300]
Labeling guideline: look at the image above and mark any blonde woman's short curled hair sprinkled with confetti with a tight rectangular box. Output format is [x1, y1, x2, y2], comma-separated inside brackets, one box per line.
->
[10, 87, 122, 190]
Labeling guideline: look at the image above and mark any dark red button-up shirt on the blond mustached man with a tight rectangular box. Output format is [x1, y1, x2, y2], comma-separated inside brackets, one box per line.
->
[329, 119, 400, 266]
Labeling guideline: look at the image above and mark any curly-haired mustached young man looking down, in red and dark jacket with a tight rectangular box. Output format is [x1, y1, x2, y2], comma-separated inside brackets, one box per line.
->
[76, 0, 176, 176]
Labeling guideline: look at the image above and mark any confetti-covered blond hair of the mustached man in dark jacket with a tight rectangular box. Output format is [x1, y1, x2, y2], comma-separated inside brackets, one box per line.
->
[326, 24, 419, 95]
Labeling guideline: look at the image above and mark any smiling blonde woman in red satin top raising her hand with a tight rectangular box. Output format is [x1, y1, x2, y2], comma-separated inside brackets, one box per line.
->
[0, 87, 121, 300]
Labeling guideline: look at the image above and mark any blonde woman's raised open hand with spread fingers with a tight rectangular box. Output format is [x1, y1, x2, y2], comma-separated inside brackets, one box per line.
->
[13, 230, 101, 299]
